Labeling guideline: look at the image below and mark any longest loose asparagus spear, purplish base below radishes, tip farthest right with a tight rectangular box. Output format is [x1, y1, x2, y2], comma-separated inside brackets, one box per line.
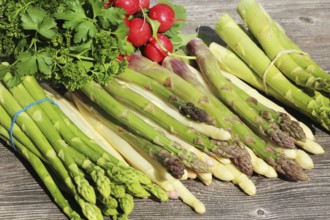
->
[129, 54, 308, 180]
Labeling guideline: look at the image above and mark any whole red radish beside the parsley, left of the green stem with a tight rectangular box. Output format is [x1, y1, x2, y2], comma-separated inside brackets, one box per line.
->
[127, 18, 152, 47]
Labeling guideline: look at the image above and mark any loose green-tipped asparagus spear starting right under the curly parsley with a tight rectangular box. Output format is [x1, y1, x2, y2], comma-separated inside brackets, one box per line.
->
[82, 82, 208, 172]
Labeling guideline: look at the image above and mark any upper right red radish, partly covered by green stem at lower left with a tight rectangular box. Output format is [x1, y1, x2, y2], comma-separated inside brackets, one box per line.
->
[148, 4, 175, 33]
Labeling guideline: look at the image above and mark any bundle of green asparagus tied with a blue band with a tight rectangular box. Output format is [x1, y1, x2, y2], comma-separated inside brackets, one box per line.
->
[0, 68, 168, 219]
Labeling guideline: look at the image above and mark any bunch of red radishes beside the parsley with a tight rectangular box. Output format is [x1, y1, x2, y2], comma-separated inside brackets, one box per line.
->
[105, 0, 183, 63]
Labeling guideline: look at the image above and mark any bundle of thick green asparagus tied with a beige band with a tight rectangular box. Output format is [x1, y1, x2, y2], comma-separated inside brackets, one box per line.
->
[215, 0, 330, 131]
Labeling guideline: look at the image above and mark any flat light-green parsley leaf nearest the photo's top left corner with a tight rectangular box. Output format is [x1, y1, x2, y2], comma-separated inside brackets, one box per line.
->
[21, 7, 56, 39]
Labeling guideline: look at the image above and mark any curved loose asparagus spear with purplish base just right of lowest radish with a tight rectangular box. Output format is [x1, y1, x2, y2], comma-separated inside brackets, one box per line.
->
[187, 38, 295, 148]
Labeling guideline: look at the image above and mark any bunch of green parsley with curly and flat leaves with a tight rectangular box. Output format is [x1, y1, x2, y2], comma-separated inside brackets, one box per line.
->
[0, 0, 134, 91]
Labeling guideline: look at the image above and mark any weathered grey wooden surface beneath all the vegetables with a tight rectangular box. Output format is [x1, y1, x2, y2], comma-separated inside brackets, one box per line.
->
[0, 0, 330, 220]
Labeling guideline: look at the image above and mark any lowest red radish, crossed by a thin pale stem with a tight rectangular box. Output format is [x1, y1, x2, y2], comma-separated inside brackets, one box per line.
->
[143, 34, 173, 63]
